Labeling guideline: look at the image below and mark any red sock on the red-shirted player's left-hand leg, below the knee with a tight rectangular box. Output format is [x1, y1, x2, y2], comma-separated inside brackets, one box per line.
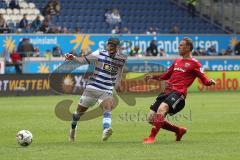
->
[149, 114, 164, 138]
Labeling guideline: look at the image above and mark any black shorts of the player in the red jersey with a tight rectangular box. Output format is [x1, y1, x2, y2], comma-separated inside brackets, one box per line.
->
[150, 91, 185, 115]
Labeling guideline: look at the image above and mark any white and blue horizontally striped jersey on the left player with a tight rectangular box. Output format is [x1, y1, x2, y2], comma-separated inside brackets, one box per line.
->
[79, 50, 127, 93]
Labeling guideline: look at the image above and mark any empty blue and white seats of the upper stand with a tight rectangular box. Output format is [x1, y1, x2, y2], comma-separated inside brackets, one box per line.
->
[0, 0, 225, 33]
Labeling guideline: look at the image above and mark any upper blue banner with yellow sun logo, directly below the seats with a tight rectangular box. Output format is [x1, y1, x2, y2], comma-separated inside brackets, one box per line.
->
[0, 34, 240, 54]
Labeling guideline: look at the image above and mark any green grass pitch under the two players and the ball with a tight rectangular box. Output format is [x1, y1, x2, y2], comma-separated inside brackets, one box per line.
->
[0, 92, 240, 160]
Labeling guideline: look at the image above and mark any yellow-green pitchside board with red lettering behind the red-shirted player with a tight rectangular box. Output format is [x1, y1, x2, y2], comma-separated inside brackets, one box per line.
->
[122, 71, 240, 93]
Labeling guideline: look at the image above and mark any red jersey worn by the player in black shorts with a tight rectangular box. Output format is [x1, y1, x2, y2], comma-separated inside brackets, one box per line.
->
[153, 58, 211, 96]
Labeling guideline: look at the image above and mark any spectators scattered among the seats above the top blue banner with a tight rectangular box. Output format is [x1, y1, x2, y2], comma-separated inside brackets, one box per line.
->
[0, 0, 212, 35]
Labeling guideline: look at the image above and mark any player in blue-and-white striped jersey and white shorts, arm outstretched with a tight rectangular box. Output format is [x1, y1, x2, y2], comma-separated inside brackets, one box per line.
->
[65, 38, 127, 141]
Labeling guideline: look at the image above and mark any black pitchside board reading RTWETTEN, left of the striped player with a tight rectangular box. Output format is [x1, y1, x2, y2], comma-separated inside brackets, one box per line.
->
[0, 74, 86, 96]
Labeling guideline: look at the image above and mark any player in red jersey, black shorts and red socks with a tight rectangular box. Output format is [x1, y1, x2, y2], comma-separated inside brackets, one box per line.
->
[143, 38, 216, 144]
